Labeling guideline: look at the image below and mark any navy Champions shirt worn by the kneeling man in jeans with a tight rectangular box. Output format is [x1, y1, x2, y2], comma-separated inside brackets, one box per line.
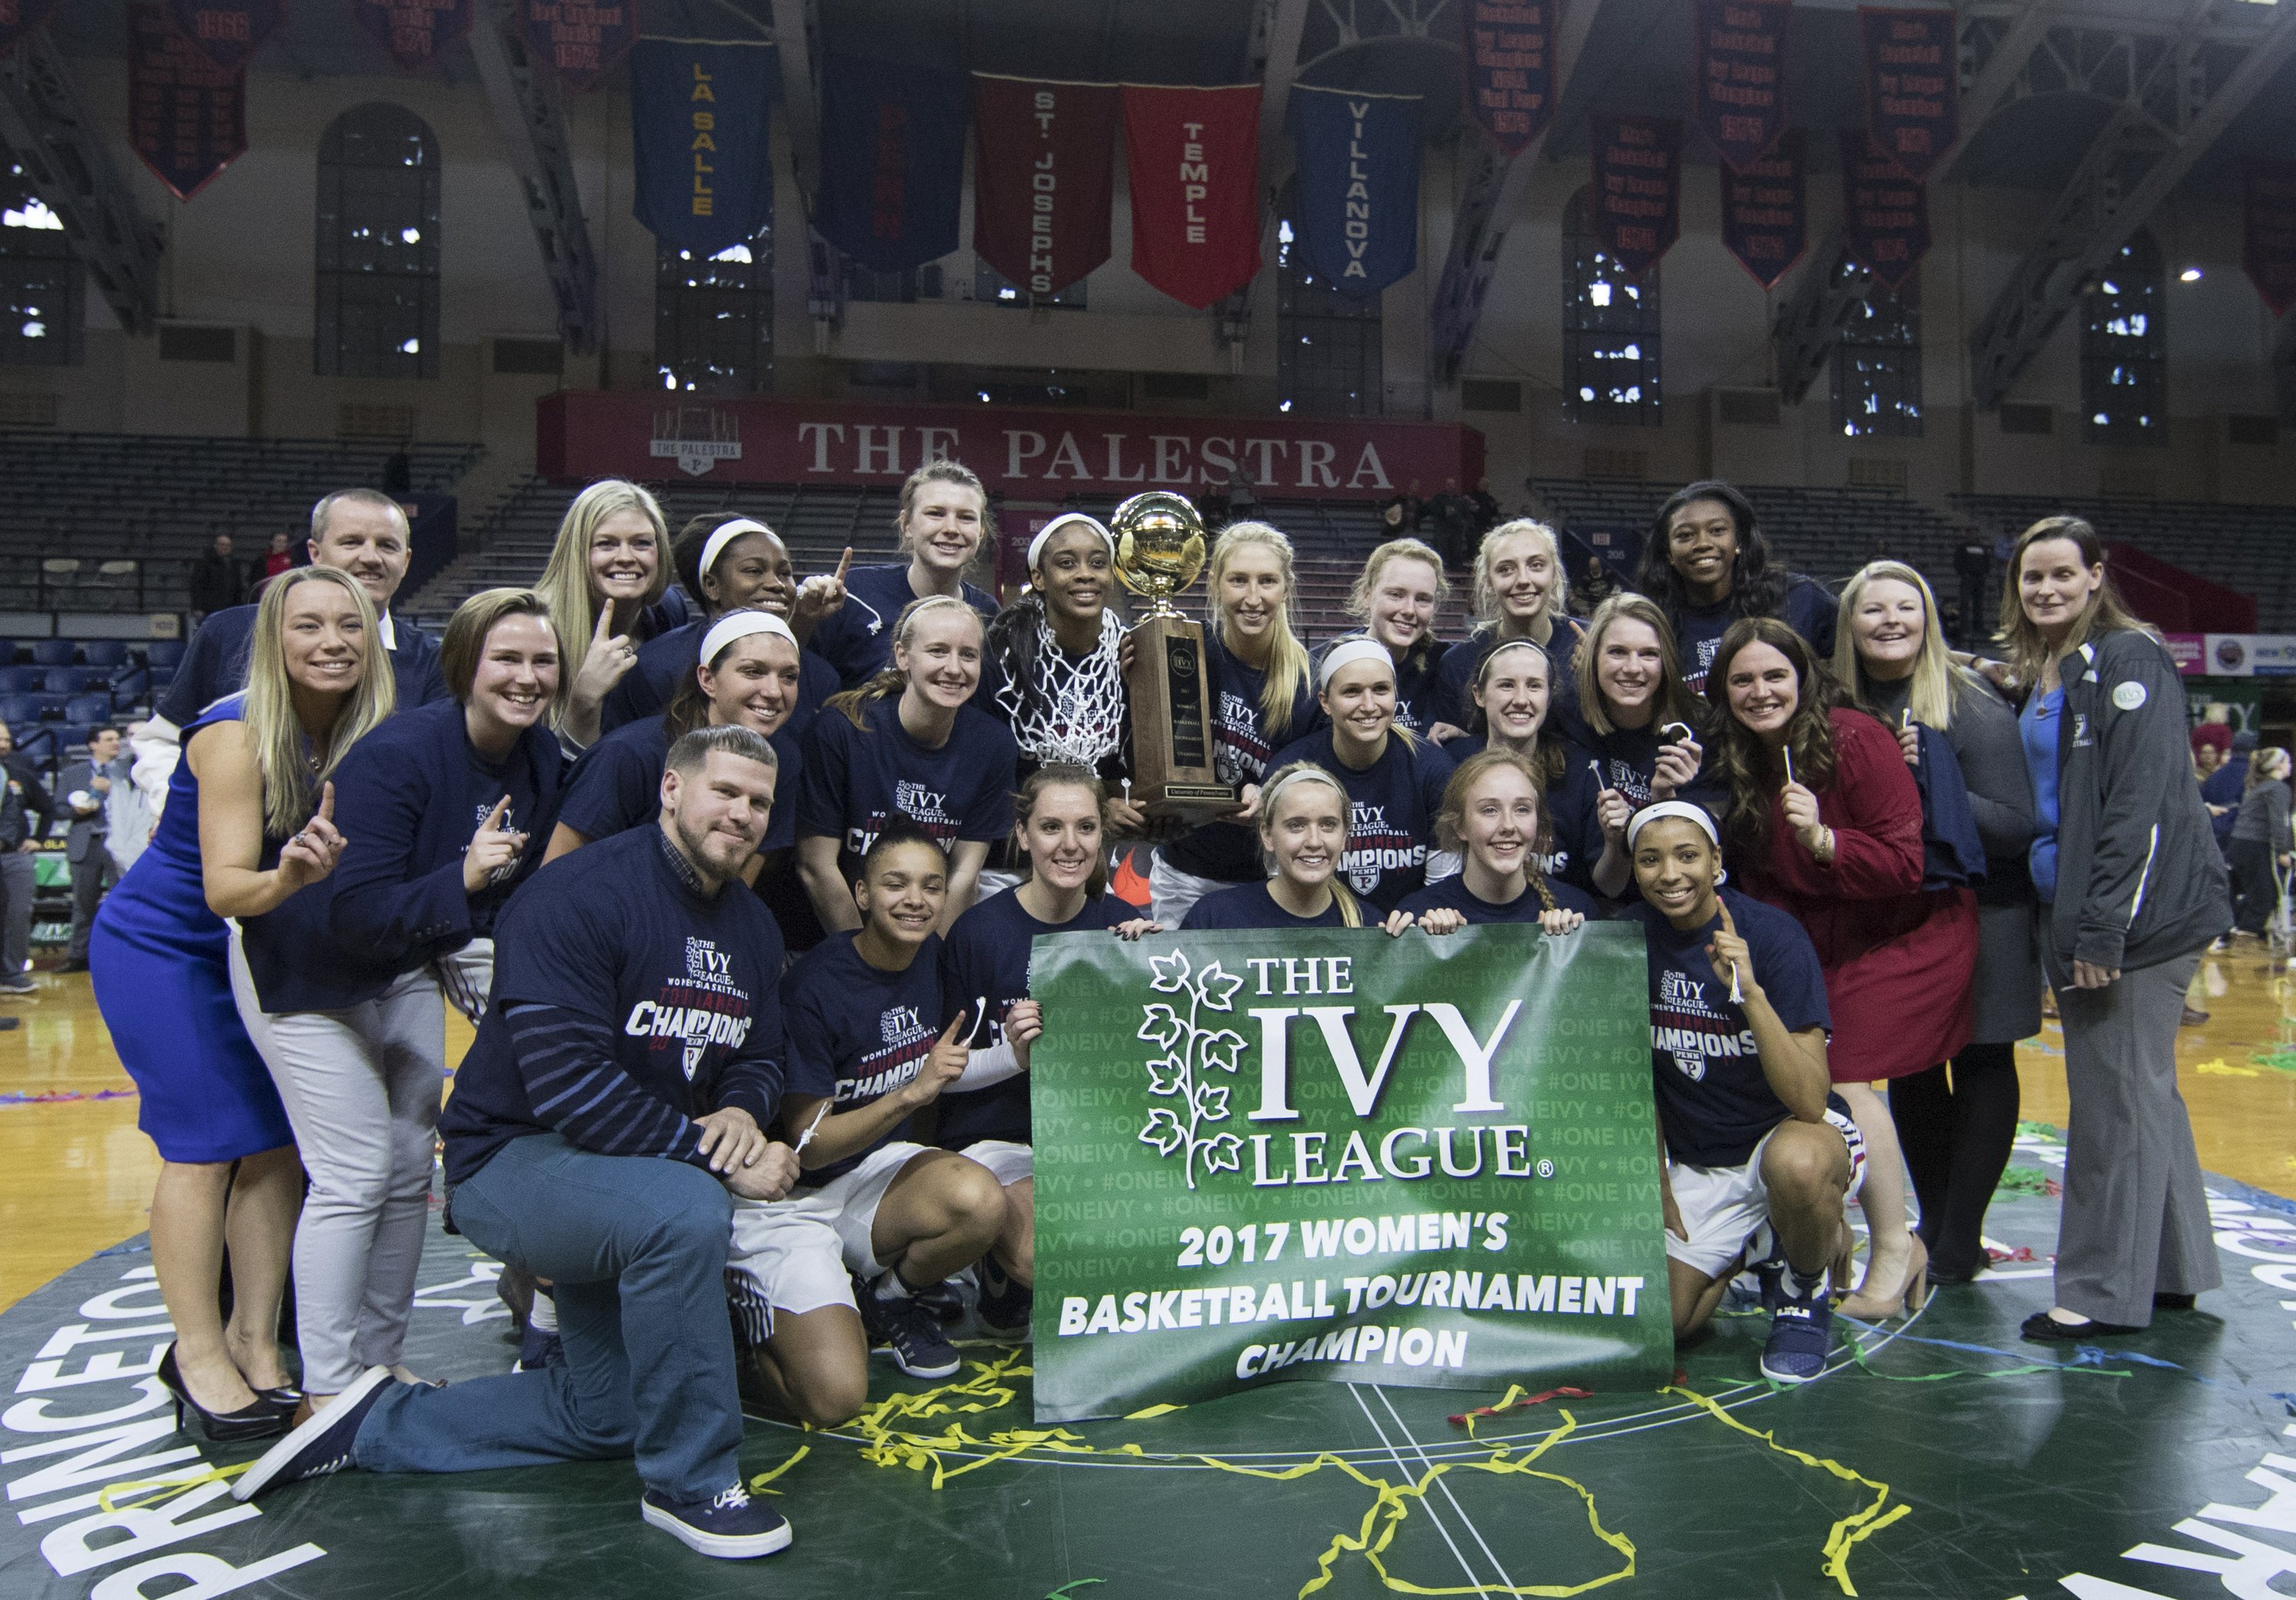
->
[439, 828, 783, 1182]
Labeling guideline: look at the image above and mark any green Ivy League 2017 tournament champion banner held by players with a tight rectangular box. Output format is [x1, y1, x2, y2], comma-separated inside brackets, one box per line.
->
[1029, 922, 1674, 1421]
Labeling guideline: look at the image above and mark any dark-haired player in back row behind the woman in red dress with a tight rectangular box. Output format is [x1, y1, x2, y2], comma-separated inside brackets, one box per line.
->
[1635, 478, 1839, 696]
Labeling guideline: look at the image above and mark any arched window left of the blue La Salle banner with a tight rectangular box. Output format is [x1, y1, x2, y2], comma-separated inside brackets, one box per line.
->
[312, 101, 439, 379]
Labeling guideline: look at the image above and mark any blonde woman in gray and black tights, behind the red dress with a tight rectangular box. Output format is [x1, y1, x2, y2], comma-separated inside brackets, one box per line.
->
[1832, 560, 2041, 1285]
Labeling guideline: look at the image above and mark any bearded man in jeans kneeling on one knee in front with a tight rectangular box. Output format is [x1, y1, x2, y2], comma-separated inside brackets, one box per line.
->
[232, 728, 797, 1556]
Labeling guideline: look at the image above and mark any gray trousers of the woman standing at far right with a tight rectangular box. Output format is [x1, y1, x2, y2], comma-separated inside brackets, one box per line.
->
[2057, 950, 2225, 1327]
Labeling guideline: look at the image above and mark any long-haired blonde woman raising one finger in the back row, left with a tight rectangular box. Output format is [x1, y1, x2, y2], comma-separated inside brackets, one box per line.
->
[535, 478, 675, 749]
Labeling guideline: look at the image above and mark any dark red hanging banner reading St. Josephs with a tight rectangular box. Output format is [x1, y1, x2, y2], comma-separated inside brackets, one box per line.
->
[974, 73, 1118, 294]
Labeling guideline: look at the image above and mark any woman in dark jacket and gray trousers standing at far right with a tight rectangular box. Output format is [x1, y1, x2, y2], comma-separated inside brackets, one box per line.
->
[2000, 517, 2232, 1340]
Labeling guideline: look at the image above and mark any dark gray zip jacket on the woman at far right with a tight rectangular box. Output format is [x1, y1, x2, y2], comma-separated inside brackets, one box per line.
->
[2050, 629, 2232, 971]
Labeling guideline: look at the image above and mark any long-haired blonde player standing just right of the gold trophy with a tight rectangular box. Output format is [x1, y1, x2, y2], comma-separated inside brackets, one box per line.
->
[1148, 521, 1322, 927]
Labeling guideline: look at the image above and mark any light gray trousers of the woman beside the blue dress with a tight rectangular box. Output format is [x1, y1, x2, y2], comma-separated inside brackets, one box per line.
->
[232, 929, 445, 1393]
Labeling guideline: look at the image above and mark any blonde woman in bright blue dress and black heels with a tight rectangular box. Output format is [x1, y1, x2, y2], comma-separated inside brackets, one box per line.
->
[87, 567, 395, 1442]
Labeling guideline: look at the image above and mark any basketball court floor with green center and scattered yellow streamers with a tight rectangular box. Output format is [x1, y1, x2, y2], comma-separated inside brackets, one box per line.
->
[0, 945, 2296, 1600]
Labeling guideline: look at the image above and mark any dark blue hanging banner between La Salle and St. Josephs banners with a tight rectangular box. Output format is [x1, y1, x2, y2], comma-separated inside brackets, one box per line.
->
[813, 55, 974, 273]
